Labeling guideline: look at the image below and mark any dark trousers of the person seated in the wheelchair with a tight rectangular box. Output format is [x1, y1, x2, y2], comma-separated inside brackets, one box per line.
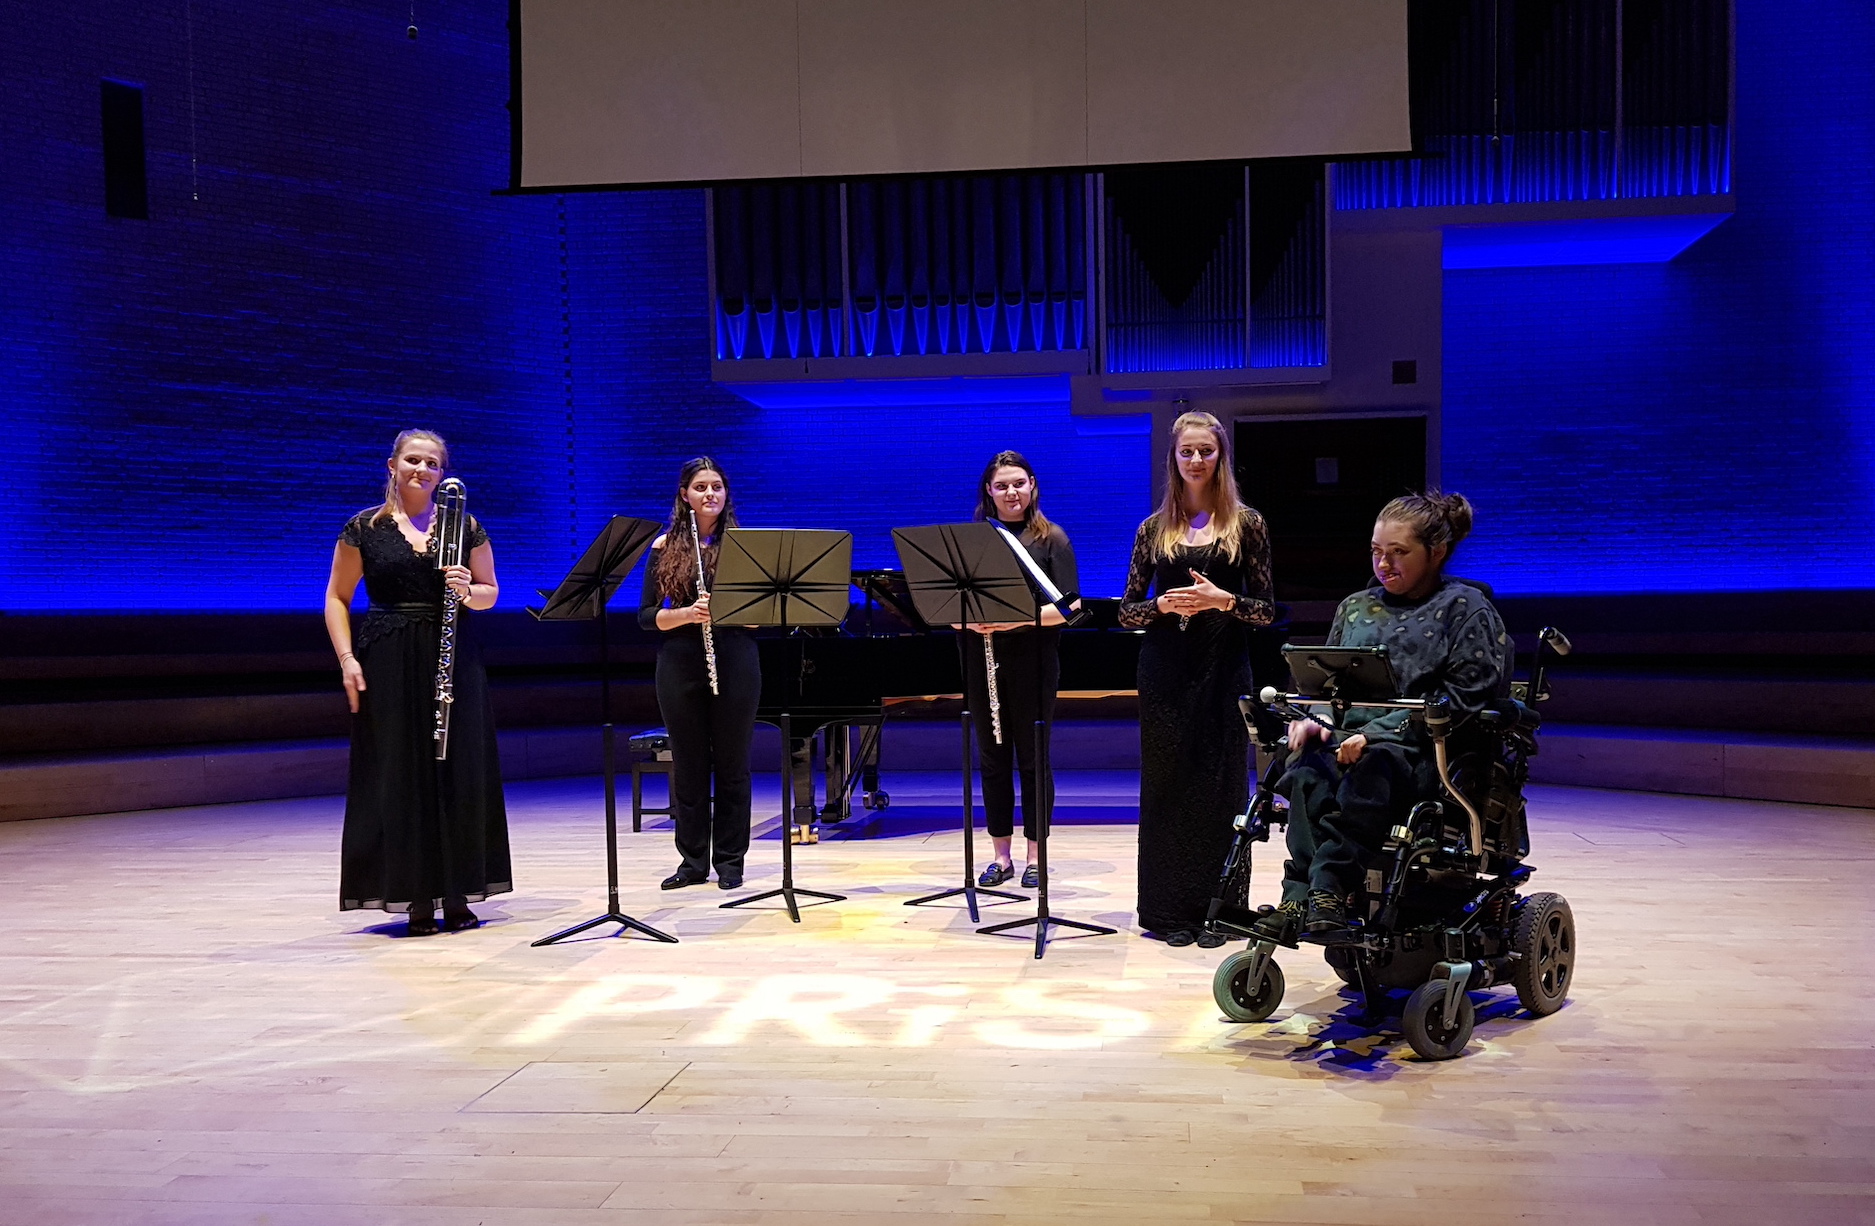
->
[1277, 740, 1438, 902]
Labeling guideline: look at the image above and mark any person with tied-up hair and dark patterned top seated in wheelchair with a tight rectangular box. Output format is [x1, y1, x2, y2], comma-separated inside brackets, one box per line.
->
[1254, 491, 1511, 945]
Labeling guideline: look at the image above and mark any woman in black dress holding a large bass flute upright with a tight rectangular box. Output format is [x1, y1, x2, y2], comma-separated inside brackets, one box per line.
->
[326, 429, 514, 935]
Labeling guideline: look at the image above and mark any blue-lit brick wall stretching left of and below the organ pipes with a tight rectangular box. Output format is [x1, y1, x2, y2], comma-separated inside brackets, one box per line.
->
[0, 0, 1149, 611]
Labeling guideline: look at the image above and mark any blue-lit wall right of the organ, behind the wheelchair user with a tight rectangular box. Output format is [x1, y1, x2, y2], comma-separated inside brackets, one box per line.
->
[1444, 0, 1875, 592]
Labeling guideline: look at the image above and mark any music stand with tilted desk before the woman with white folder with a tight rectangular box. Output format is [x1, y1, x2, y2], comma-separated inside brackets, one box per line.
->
[893, 523, 1039, 924]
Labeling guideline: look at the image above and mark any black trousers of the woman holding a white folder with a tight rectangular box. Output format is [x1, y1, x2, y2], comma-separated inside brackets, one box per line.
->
[964, 630, 1061, 838]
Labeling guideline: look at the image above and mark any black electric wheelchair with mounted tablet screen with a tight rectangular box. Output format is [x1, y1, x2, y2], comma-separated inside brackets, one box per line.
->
[1206, 628, 1575, 1059]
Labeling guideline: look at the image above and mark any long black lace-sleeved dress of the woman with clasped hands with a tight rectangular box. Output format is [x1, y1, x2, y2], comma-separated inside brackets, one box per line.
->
[1119, 508, 1275, 934]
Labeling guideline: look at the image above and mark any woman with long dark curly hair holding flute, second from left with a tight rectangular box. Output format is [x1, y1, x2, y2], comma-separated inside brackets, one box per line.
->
[638, 456, 761, 890]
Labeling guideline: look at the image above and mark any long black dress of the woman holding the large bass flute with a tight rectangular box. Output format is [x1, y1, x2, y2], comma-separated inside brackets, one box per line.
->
[339, 512, 514, 913]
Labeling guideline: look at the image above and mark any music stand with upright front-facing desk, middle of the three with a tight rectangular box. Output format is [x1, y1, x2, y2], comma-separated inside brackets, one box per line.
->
[709, 529, 853, 924]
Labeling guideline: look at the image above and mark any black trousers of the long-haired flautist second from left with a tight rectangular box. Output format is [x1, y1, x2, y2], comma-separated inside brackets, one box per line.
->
[656, 630, 761, 877]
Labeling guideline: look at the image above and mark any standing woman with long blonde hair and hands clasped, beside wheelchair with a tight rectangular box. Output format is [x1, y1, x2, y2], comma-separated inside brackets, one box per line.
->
[1119, 412, 1275, 945]
